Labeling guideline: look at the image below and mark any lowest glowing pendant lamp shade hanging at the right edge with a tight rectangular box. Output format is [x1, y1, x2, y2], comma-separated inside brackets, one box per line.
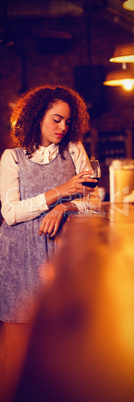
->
[103, 70, 134, 91]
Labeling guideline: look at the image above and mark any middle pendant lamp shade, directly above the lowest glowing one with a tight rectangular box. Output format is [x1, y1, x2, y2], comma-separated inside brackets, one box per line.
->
[110, 43, 134, 63]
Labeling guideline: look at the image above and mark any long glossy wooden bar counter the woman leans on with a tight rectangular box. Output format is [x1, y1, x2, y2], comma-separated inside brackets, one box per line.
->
[2, 203, 134, 402]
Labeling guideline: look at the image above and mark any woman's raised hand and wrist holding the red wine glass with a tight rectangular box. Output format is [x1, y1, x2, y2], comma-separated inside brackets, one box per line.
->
[56, 169, 97, 197]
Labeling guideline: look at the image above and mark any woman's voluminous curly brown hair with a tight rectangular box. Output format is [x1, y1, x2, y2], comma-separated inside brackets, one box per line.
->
[11, 85, 89, 156]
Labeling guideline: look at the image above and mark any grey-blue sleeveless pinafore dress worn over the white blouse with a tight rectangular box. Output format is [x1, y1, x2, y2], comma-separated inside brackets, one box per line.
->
[0, 148, 75, 323]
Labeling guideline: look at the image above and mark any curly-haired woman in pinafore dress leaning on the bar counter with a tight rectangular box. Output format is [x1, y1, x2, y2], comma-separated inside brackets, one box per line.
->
[0, 86, 98, 323]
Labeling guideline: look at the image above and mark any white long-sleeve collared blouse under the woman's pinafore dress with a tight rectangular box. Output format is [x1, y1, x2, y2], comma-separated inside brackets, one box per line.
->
[1, 141, 89, 225]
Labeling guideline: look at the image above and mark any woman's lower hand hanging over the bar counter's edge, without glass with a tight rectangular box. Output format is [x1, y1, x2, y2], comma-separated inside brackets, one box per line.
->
[39, 204, 66, 237]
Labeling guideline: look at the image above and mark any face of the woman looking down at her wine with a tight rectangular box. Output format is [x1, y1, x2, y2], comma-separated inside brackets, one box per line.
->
[40, 100, 71, 147]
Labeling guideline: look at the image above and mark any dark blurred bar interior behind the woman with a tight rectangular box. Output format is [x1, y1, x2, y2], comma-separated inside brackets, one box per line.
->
[0, 0, 134, 200]
